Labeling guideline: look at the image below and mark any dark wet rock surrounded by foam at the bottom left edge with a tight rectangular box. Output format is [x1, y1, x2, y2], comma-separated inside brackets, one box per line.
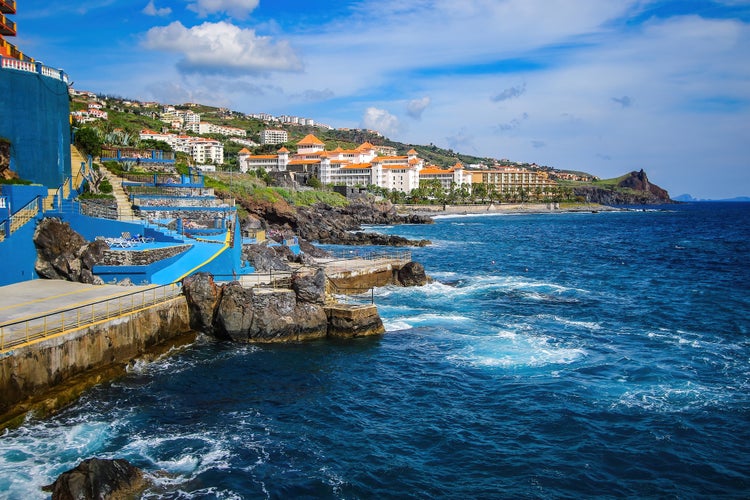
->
[43, 458, 148, 500]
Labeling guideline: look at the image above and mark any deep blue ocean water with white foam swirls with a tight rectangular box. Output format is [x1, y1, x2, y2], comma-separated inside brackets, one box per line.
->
[0, 204, 750, 499]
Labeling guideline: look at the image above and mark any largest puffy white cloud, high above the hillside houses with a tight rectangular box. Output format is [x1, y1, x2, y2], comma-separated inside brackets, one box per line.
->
[144, 21, 302, 74]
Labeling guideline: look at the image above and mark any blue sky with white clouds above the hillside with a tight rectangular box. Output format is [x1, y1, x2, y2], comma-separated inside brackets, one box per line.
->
[12, 0, 750, 199]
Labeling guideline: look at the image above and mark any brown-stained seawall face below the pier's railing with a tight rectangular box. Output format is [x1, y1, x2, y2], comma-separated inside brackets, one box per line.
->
[0, 296, 195, 428]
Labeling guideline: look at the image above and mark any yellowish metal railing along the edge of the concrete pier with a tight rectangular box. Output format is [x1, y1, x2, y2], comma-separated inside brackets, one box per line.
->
[0, 283, 182, 354]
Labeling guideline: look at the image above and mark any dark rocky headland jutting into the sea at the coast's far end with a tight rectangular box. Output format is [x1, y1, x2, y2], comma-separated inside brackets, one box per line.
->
[573, 169, 673, 205]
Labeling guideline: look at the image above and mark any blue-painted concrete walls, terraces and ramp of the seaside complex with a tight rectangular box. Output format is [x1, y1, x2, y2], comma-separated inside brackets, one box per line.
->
[0, 57, 299, 285]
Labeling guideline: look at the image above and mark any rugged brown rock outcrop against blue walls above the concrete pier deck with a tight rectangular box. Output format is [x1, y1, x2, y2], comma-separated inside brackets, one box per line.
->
[34, 217, 109, 284]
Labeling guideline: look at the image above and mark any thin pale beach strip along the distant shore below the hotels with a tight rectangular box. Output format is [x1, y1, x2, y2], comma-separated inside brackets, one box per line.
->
[397, 203, 620, 217]
